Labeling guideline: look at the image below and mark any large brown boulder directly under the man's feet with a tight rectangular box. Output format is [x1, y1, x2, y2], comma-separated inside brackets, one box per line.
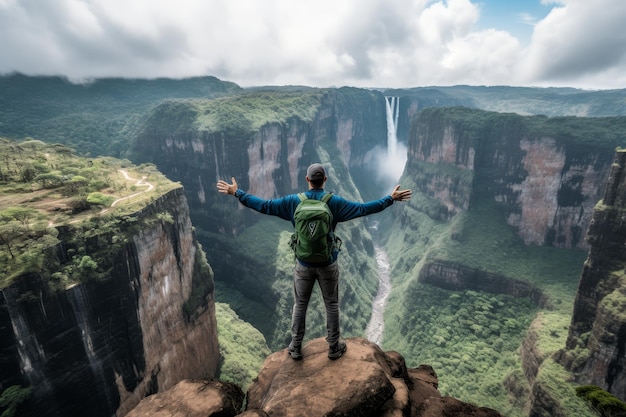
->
[241, 338, 500, 417]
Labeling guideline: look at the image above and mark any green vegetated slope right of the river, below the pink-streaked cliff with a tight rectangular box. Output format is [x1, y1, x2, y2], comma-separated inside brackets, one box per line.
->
[383, 203, 586, 417]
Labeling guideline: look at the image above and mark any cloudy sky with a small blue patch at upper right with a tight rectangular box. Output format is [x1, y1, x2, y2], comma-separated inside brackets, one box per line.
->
[0, 0, 626, 89]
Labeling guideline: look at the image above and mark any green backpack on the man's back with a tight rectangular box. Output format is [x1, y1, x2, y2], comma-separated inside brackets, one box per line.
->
[291, 193, 339, 263]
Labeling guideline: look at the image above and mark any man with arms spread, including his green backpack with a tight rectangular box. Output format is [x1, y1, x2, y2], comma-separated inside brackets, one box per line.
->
[217, 163, 411, 359]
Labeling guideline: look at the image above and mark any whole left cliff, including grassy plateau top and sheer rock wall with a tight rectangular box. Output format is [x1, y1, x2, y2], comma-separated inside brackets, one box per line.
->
[0, 139, 220, 417]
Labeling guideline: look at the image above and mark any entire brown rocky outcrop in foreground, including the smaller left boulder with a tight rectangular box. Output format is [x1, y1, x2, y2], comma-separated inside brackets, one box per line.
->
[129, 338, 501, 417]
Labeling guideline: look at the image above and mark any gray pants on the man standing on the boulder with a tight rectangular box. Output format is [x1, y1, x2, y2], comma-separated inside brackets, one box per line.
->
[291, 262, 339, 346]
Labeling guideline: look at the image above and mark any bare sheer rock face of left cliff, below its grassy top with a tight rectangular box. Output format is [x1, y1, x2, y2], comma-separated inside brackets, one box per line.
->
[0, 188, 219, 416]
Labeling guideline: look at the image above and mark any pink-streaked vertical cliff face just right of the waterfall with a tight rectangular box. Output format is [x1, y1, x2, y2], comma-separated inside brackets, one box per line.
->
[408, 108, 615, 248]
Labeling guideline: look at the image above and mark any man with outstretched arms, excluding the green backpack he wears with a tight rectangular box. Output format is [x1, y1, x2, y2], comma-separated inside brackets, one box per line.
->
[217, 163, 411, 359]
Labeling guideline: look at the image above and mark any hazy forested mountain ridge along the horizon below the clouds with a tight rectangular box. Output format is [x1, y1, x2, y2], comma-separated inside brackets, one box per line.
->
[0, 73, 626, 157]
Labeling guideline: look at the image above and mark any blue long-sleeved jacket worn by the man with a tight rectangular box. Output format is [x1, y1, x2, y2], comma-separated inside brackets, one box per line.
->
[235, 189, 393, 266]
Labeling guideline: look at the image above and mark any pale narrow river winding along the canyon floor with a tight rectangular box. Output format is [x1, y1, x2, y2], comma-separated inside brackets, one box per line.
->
[365, 245, 391, 344]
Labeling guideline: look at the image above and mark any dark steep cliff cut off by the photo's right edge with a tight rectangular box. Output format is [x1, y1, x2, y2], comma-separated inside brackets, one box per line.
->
[561, 150, 626, 400]
